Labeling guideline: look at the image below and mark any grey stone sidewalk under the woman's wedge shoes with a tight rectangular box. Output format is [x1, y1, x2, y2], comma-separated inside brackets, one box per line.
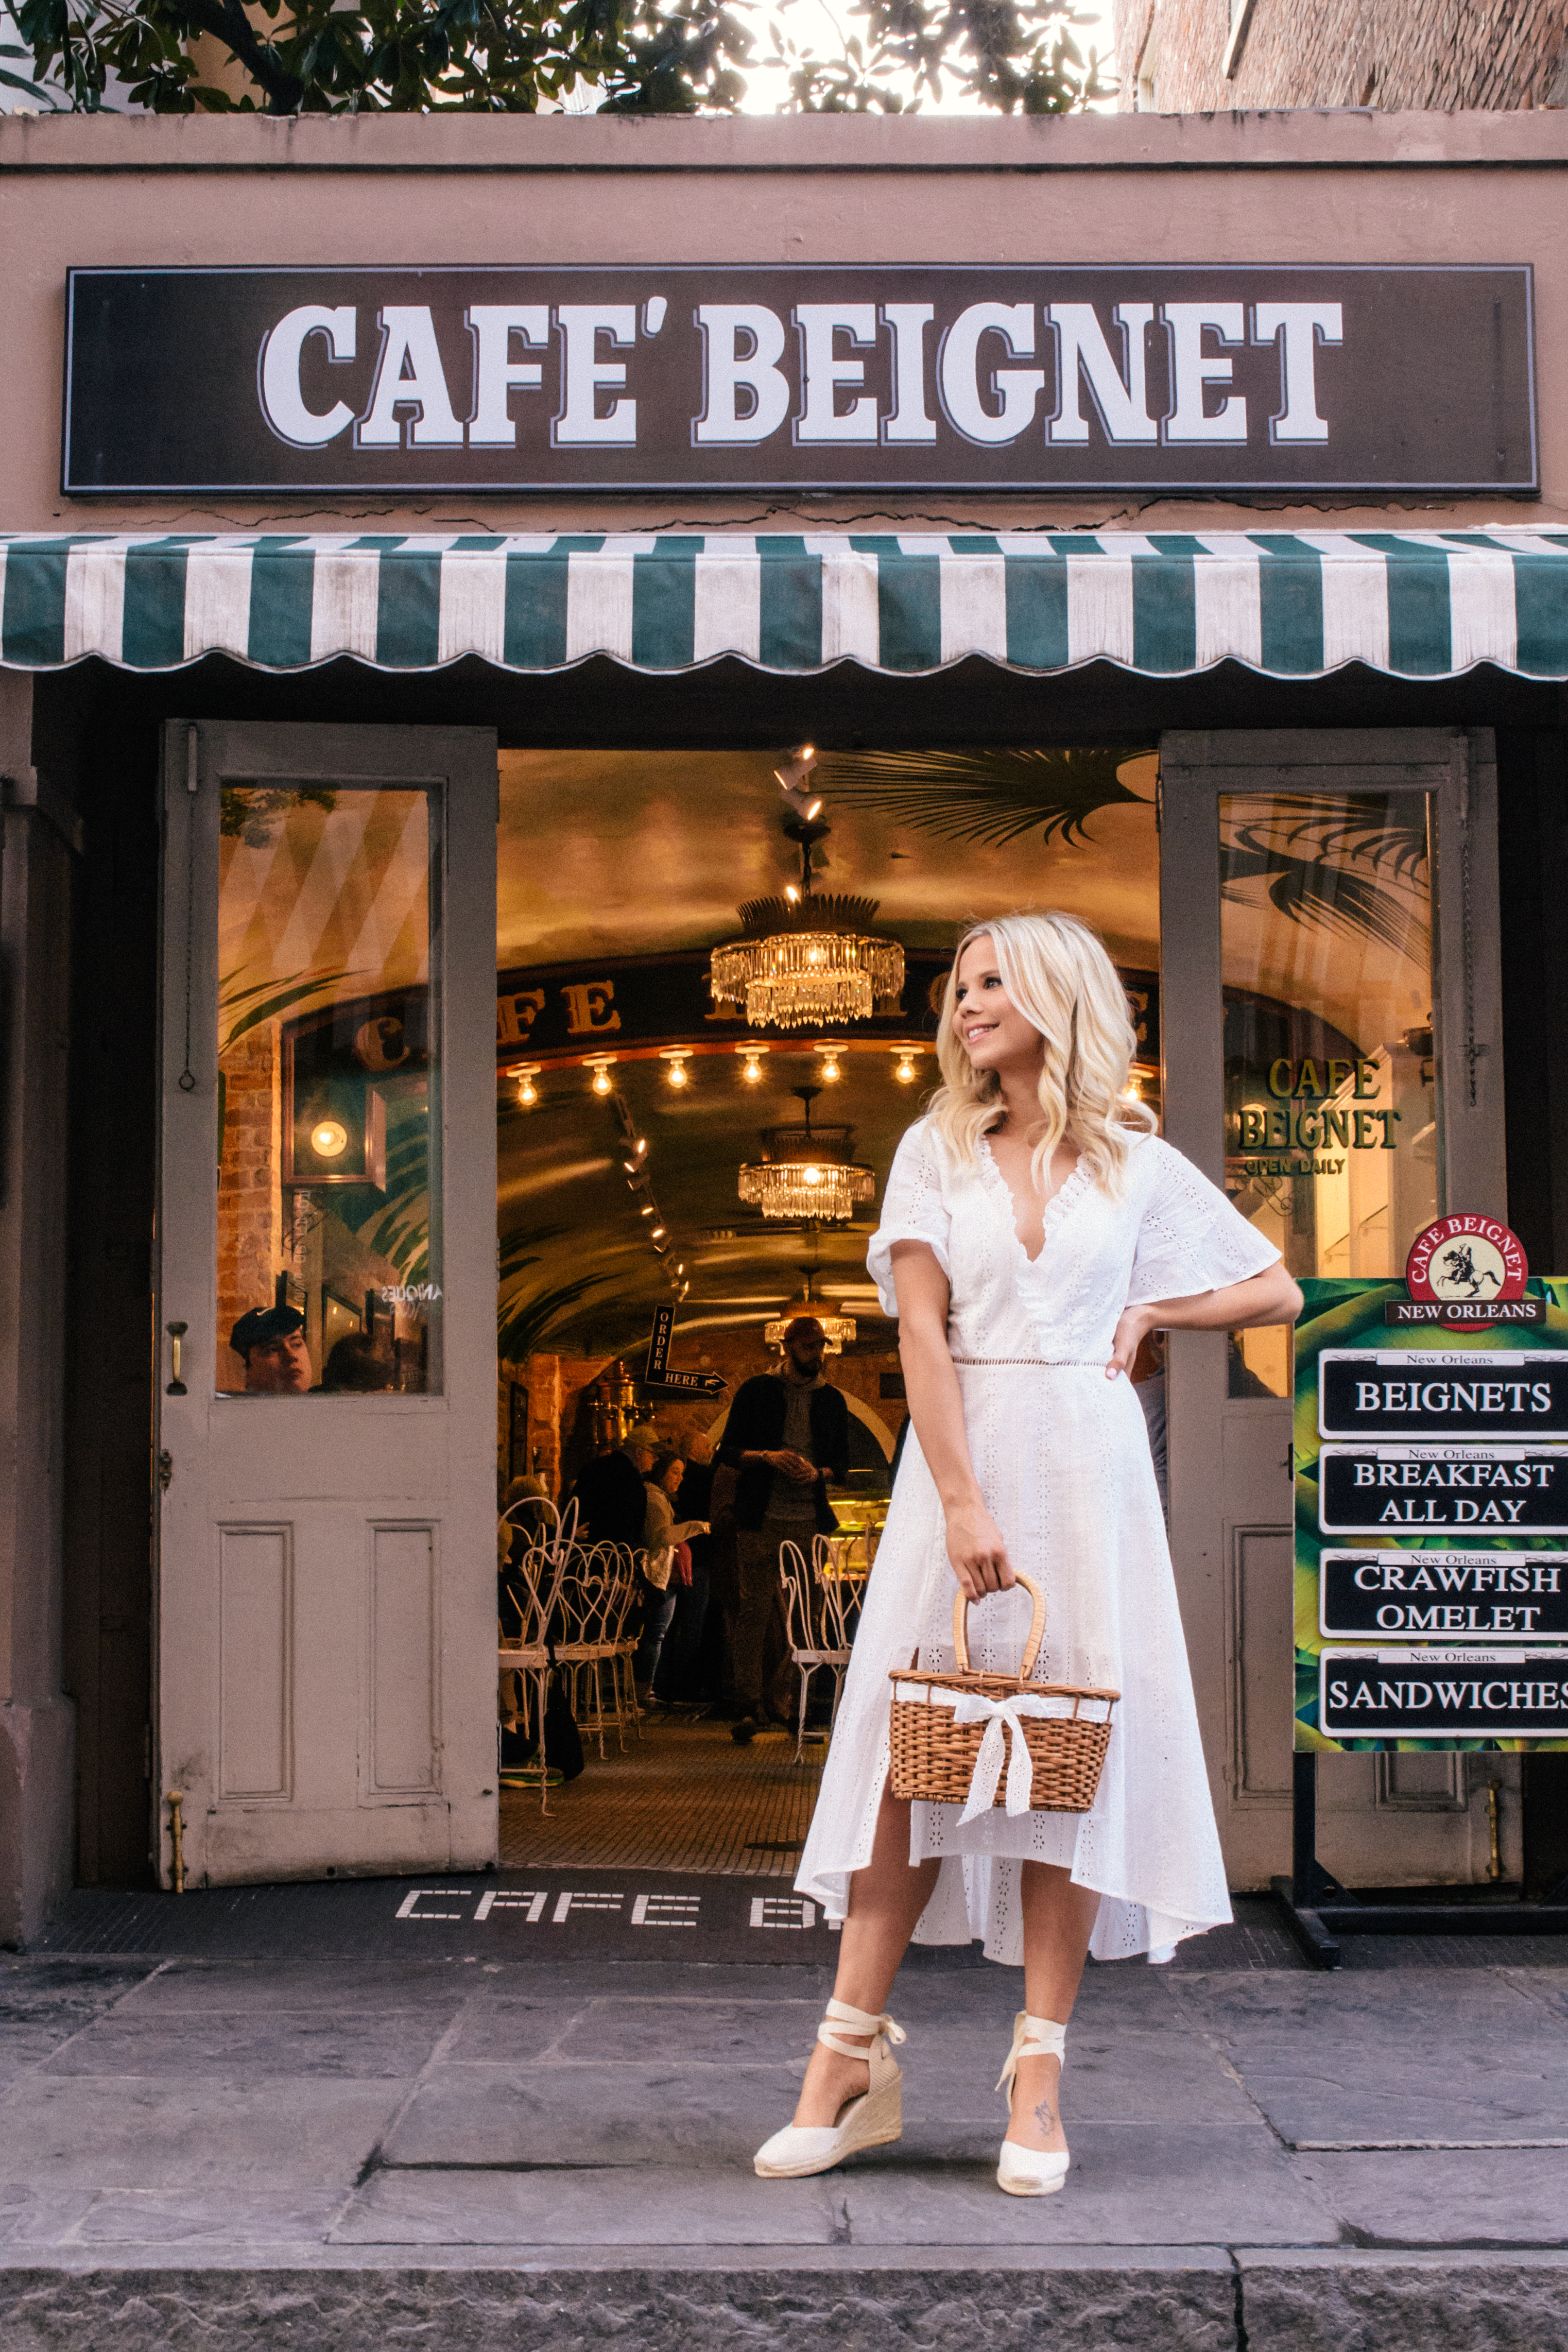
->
[0, 1910, 1568, 2352]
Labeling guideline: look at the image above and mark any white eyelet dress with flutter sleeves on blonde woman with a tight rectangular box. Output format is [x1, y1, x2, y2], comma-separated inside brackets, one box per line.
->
[795, 1120, 1279, 1966]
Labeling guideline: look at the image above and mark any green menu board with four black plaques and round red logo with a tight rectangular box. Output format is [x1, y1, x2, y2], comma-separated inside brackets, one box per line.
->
[1295, 1251, 1568, 1750]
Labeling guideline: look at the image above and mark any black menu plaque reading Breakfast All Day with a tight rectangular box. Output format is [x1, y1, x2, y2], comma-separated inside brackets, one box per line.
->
[1319, 1447, 1568, 1540]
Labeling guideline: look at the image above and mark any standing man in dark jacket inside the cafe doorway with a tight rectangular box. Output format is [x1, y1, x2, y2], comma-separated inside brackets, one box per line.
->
[719, 1315, 849, 1741]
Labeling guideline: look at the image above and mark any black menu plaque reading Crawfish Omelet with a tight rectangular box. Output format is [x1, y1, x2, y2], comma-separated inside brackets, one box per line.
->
[1319, 1546, 1568, 1642]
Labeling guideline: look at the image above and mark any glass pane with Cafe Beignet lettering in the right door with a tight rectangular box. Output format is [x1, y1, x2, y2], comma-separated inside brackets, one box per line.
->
[1220, 793, 1441, 1395]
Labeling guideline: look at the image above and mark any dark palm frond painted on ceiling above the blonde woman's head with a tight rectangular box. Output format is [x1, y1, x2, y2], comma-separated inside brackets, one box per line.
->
[816, 743, 1152, 849]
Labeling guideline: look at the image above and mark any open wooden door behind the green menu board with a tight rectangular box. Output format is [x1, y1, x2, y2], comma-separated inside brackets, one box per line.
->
[1159, 729, 1519, 1889]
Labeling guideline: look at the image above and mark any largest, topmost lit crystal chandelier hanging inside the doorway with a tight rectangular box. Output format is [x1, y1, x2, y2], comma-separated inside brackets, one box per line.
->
[710, 743, 903, 1030]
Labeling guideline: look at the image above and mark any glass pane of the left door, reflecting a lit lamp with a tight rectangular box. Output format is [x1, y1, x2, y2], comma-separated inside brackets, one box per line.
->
[216, 783, 442, 1395]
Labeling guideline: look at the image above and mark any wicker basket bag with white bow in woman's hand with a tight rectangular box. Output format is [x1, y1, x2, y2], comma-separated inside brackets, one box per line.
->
[889, 1576, 1122, 1821]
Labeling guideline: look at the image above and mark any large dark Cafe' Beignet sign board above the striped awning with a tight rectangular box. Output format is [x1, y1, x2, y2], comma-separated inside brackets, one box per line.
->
[61, 264, 1538, 494]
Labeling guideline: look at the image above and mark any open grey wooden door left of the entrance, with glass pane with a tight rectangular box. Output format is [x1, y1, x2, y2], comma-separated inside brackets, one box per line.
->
[155, 722, 496, 1884]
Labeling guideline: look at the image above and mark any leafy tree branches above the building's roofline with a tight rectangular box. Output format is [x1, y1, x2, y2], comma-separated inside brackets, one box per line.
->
[18, 0, 1112, 115]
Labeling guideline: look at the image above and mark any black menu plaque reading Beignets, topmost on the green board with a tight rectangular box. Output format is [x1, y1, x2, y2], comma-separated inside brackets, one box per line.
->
[1317, 1348, 1568, 1439]
